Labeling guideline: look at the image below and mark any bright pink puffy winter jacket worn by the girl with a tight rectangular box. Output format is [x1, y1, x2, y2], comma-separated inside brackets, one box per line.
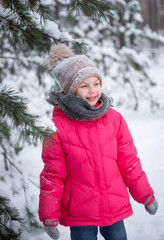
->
[39, 108, 154, 226]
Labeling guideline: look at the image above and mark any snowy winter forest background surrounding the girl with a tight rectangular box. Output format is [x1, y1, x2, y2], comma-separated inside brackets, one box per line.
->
[0, 0, 164, 240]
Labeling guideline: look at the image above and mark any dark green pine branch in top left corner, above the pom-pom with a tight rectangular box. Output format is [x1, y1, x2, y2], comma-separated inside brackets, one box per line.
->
[0, 0, 91, 53]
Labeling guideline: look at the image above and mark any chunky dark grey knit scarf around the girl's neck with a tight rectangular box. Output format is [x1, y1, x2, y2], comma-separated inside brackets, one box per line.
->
[47, 91, 111, 121]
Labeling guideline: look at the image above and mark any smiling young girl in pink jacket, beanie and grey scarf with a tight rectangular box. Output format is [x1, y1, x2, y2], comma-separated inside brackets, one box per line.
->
[39, 45, 158, 240]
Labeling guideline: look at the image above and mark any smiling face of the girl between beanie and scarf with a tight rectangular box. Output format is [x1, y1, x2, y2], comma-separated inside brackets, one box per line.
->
[75, 76, 101, 107]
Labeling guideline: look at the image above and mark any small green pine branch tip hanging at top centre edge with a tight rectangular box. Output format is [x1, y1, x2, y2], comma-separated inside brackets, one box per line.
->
[68, 0, 114, 21]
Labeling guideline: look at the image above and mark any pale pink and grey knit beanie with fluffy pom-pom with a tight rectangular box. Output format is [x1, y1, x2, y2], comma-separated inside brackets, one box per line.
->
[48, 45, 102, 94]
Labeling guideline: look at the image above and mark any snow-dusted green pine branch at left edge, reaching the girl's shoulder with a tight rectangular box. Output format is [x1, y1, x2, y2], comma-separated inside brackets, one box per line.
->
[0, 86, 52, 144]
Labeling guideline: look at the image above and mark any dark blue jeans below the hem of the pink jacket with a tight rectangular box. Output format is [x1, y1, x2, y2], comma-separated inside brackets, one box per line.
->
[70, 221, 127, 240]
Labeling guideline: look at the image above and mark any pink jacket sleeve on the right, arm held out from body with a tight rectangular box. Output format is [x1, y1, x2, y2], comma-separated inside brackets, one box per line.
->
[117, 116, 154, 203]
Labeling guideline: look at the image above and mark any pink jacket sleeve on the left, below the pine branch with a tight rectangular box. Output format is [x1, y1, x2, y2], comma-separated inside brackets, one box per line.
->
[39, 134, 67, 221]
